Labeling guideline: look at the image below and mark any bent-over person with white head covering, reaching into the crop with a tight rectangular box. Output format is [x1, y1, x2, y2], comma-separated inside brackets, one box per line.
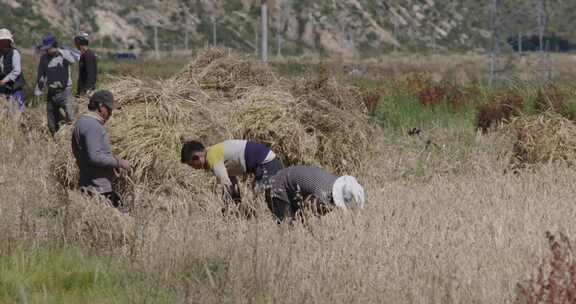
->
[266, 166, 364, 222]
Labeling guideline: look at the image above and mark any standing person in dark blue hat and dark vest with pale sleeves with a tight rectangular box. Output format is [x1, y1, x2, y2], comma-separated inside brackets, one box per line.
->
[34, 34, 76, 135]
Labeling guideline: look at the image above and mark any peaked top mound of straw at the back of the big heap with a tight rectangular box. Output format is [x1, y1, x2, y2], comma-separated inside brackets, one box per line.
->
[173, 48, 276, 97]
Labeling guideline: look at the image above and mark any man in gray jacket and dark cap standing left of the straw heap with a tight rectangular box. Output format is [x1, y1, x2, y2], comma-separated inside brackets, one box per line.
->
[72, 91, 130, 207]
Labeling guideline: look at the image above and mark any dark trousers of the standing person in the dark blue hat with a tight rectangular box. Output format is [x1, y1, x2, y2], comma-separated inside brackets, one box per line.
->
[46, 88, 74, 135]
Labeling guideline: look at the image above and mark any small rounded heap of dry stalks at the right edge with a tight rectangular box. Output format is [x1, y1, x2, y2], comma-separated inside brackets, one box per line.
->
[511, 112, 576, 166]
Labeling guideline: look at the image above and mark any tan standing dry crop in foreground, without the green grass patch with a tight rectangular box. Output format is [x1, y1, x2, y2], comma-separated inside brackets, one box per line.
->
[0, 98, 576, 303]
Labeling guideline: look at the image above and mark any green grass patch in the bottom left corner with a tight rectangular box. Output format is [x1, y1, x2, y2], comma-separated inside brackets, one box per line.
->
[0, 248, 175, 303]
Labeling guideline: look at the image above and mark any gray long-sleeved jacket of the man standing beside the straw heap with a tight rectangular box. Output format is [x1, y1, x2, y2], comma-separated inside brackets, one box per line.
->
[72, 112, 120, 193]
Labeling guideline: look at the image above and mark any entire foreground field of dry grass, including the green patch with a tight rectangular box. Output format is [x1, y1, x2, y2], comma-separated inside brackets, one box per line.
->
[0, 48, 576, 303]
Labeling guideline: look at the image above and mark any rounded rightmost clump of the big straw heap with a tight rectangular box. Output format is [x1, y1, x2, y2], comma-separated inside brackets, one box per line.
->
[292, 78, 375, 173]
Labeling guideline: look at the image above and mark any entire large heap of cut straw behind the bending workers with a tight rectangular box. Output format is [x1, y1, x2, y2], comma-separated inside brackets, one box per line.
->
[53, 49, 373, 193]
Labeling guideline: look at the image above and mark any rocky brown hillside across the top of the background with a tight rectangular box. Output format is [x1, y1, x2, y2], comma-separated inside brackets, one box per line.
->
[0, 0, 576, 56]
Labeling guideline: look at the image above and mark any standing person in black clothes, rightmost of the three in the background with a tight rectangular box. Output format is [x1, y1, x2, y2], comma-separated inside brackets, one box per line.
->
[74, 33, 98, 97]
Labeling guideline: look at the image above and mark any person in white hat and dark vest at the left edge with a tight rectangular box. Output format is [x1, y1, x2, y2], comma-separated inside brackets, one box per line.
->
[0, 29, 25, 116]
